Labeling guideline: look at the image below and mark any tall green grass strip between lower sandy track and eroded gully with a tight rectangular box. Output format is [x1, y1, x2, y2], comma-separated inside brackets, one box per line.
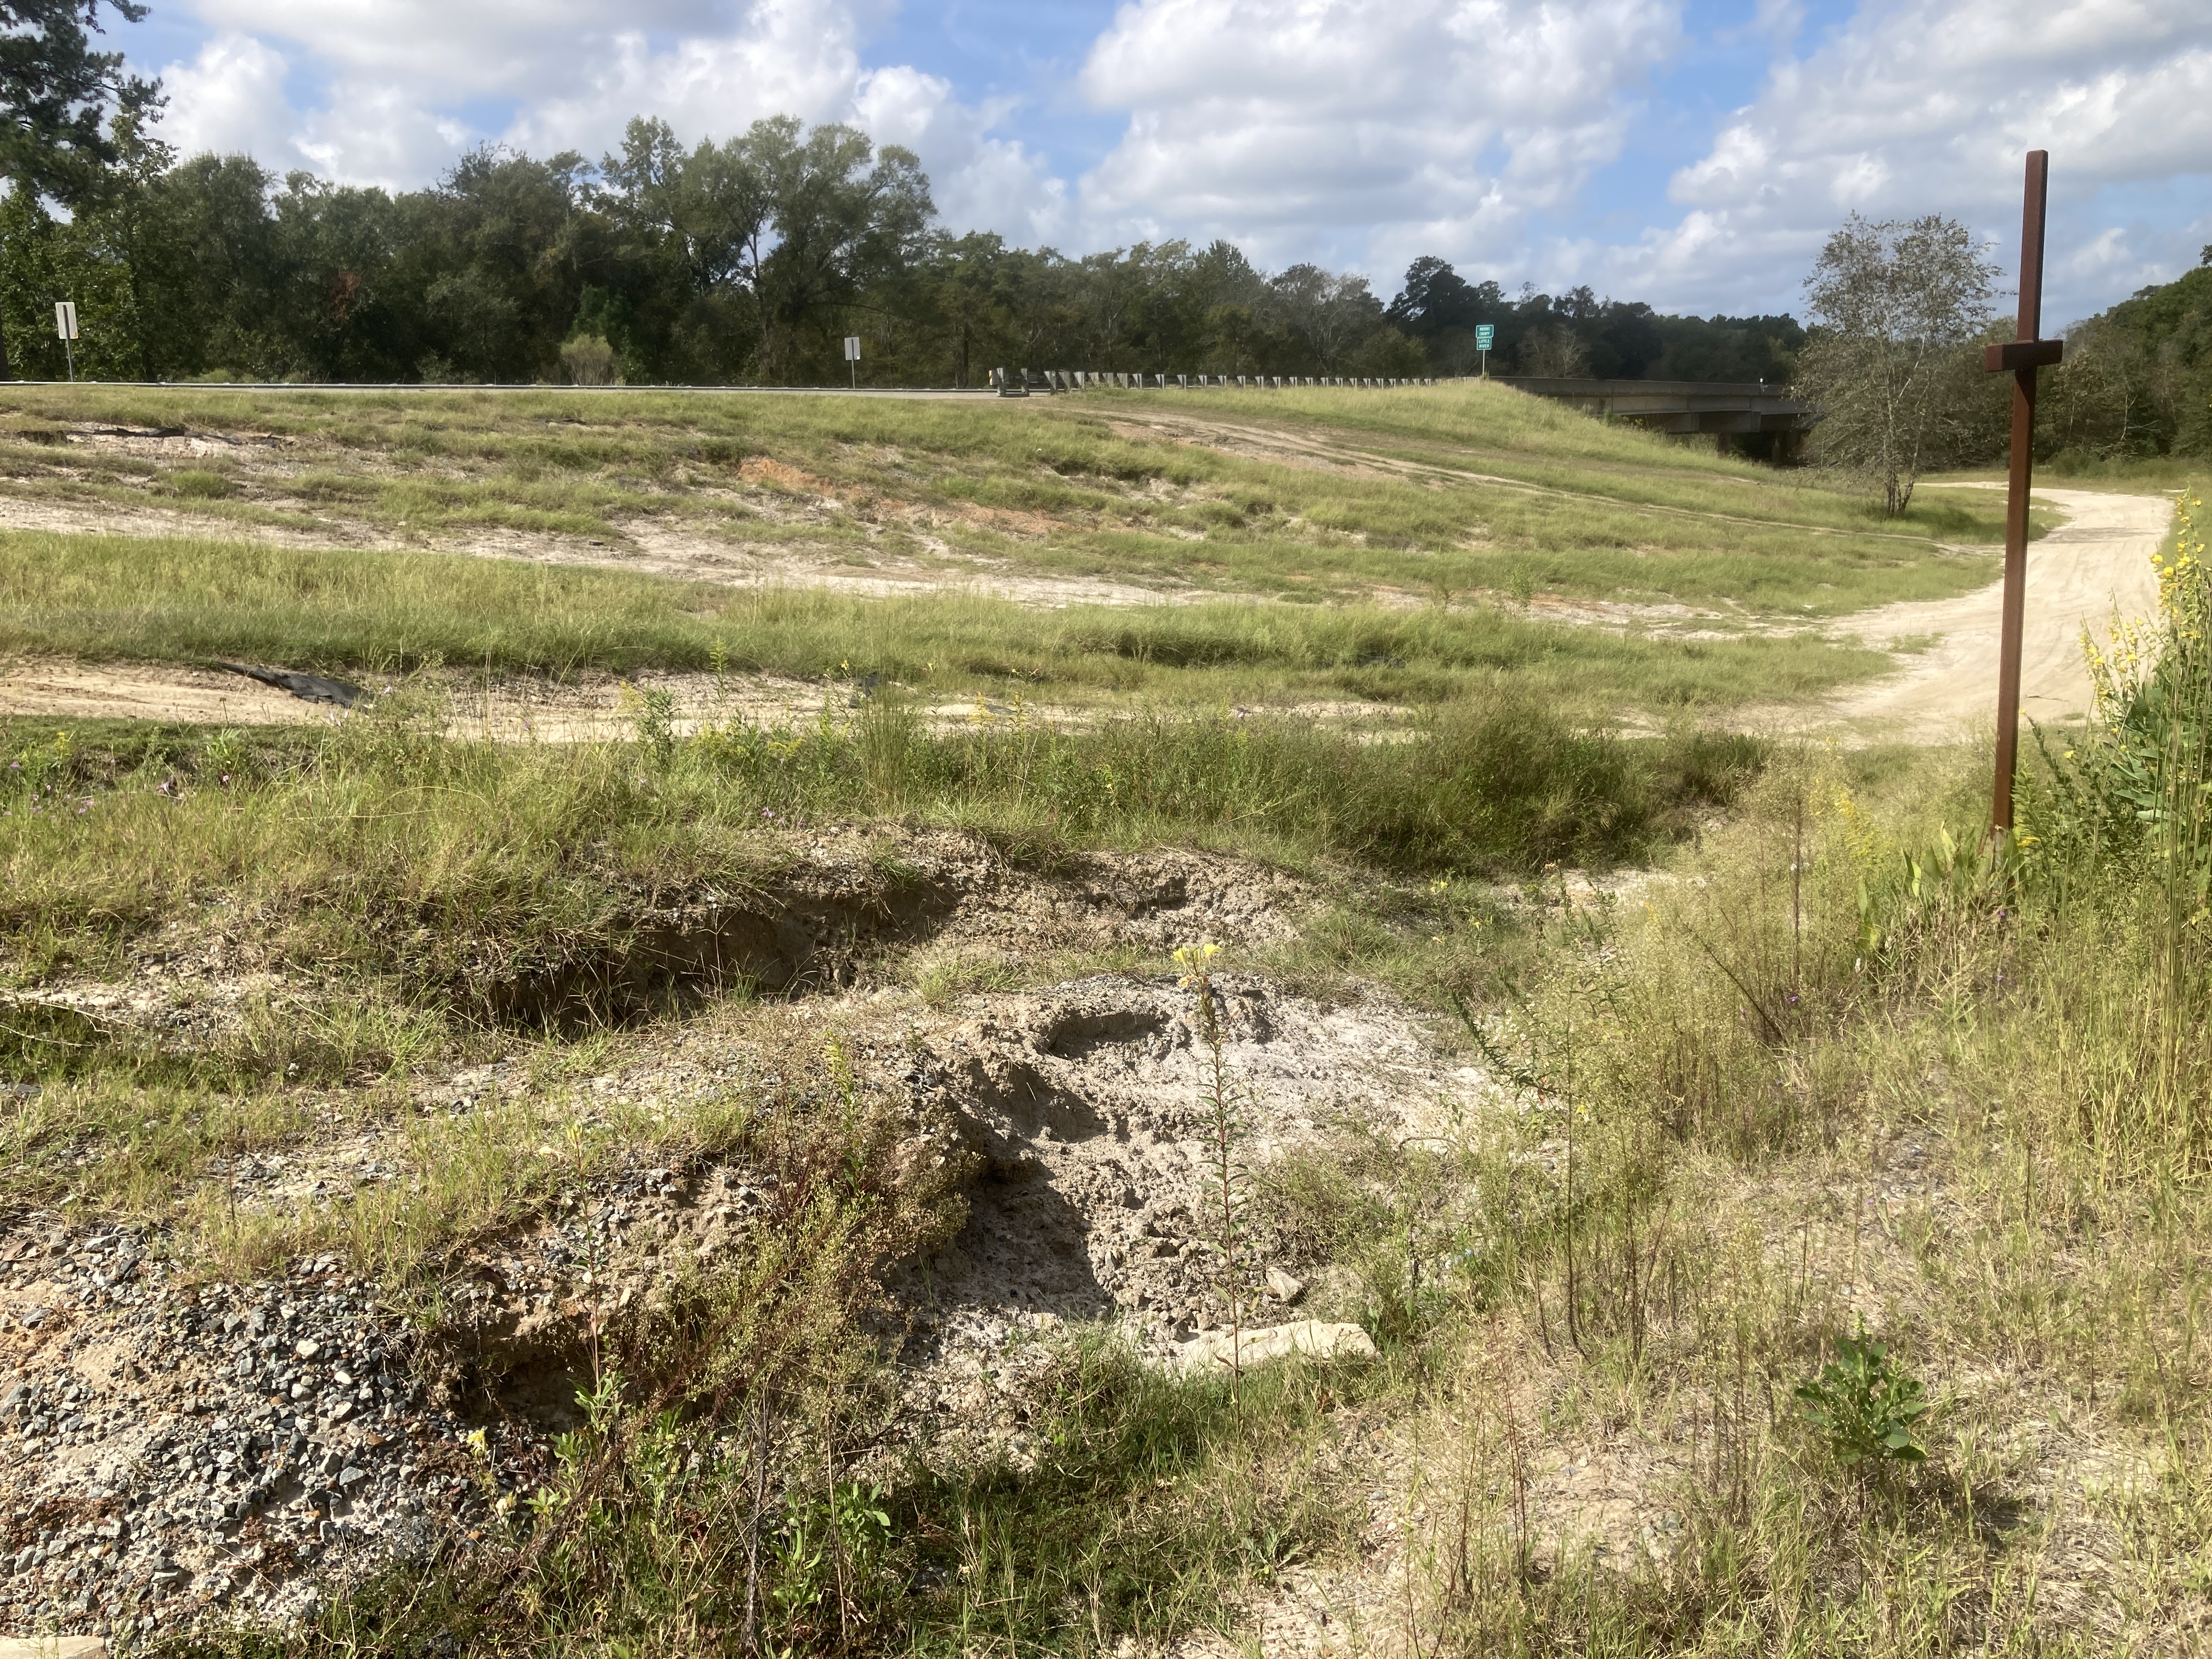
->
[0, 699, 1758, 1026]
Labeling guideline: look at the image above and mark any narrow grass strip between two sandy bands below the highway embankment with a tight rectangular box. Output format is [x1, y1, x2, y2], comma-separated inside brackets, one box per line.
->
[0, 535, 1889, 712]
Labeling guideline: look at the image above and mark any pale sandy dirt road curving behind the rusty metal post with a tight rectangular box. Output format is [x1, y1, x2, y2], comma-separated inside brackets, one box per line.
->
[1822, 484, 2174, 743]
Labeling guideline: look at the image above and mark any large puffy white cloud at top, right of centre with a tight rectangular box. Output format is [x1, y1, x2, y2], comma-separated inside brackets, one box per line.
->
[1082, 0, 1679, 263]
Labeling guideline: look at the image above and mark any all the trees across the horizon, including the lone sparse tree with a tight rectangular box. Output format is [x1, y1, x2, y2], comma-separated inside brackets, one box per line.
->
[0, 0, 2212, 511]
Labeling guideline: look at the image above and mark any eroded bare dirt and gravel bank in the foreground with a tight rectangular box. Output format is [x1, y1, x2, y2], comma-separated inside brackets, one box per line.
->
[0, 836, 1491, 1637]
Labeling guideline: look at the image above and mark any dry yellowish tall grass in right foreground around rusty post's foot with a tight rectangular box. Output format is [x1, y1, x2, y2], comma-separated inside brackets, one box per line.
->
[1292, 487, 2212, 1657]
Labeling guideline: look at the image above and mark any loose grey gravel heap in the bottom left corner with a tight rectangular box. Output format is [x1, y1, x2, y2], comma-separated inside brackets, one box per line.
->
[0, 1215, 538, 1635]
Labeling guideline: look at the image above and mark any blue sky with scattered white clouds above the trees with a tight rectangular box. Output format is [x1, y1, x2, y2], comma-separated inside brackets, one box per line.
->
[133, 0, 2212, 319]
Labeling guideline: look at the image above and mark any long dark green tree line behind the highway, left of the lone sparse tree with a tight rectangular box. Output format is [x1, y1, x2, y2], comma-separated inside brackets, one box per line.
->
[0, 97, 1803, 385]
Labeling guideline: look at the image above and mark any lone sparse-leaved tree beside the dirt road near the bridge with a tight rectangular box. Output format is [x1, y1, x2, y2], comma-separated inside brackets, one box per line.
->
[1794, 212, 1997, 517]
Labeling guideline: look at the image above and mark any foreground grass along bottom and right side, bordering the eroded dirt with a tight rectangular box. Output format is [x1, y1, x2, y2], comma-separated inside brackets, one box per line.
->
[125, 498, 2212, 1659]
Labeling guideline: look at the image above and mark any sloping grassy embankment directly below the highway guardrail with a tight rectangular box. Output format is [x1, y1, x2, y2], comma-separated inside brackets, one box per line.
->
[0, 376, 2002, 617]
